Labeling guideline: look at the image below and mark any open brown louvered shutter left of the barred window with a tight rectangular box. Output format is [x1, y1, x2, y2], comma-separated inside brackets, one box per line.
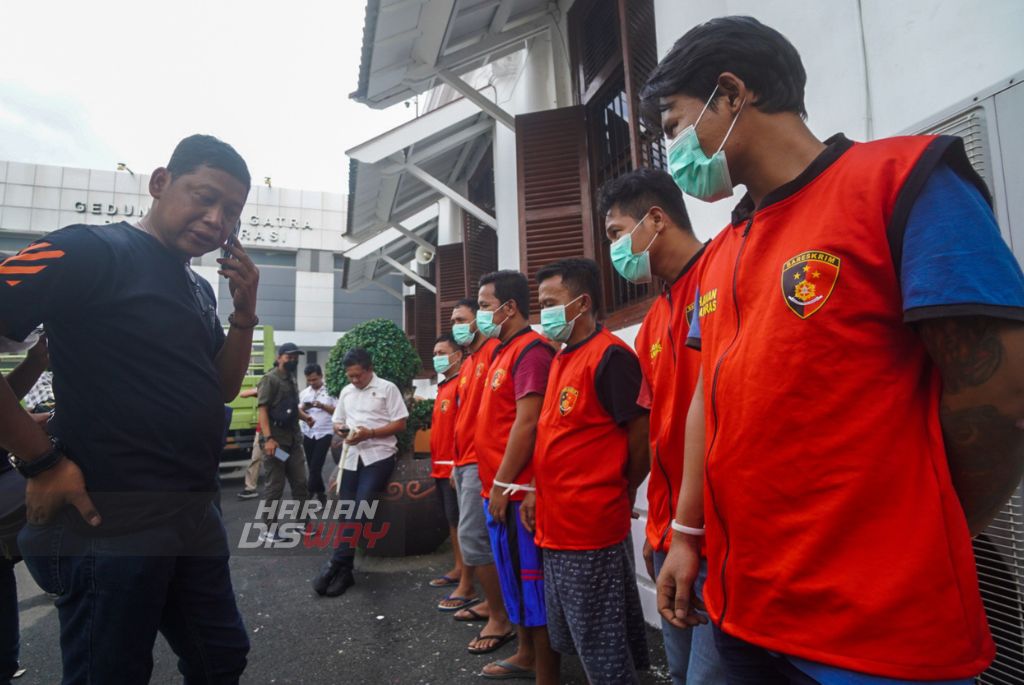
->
[515, 105, 594, 319]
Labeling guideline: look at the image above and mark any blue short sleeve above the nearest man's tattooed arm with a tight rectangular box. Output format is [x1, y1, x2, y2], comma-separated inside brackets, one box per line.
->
[900, 164, 1024, 322]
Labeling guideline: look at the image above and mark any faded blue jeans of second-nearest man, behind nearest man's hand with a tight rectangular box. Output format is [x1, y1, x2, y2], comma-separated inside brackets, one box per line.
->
[654, 552, 725, 685]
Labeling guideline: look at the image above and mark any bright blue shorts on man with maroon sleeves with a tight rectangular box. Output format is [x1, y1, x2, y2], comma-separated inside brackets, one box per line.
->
[483, 499, 548, 628]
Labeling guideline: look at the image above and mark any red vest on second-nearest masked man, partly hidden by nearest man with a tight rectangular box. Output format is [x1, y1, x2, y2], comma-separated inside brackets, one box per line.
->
[636, 252, 702, 552]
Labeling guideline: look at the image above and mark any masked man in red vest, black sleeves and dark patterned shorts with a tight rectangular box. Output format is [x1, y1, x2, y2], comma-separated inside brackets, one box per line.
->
[532, 259, 650, 685]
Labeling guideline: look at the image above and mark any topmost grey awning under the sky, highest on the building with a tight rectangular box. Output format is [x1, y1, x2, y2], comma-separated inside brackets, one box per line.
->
[349, 0, 558, 109]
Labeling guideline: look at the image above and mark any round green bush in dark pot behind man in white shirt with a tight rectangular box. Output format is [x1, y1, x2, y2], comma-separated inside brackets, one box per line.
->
[324, 318, 447, 556]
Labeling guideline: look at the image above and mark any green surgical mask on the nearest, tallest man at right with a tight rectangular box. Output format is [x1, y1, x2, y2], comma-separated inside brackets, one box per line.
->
[669, 86, 746, 202]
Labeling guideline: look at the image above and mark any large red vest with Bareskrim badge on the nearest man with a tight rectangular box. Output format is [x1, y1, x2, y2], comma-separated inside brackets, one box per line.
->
[696, 136, 994, 680]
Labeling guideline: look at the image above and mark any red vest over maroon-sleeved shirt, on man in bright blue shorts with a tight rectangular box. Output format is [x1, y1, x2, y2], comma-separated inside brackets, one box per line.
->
[476, 328, 548, 501]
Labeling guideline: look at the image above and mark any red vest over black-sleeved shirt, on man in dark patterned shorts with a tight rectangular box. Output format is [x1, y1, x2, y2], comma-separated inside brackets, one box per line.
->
[534, 328, 633, 550]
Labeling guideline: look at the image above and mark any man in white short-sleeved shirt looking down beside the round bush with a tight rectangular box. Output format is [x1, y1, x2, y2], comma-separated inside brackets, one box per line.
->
[313, 347, 409, 597]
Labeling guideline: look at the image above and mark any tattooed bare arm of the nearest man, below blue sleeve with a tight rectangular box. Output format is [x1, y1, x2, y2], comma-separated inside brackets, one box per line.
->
[918, 316, 1024, 534]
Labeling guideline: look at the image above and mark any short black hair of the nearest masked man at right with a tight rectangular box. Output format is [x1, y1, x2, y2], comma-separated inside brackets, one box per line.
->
[640, 16, 807, 129]
